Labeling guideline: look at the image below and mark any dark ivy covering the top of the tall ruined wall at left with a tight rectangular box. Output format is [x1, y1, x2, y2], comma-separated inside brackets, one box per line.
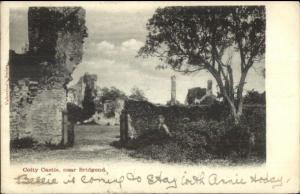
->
[28, 7, 88, 73]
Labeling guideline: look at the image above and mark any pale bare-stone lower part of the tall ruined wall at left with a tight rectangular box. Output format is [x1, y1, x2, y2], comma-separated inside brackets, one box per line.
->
[10, 80, 67, 144]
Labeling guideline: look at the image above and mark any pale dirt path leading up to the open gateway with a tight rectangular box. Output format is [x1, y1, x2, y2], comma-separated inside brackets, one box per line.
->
[11, 125, 136, 163]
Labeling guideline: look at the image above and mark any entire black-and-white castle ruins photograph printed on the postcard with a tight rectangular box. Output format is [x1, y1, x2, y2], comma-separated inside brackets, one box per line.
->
[9, 6, 266, 165]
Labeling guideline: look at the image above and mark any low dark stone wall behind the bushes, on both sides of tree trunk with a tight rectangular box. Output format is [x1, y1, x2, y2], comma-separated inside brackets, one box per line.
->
[120, 100, 266, 142]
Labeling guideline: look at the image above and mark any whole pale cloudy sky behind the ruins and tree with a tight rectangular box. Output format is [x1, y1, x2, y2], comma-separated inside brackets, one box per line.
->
[10, 4, 265, 104]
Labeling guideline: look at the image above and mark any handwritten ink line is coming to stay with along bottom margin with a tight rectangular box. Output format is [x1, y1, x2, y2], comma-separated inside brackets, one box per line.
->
[14, 168, 290, 190]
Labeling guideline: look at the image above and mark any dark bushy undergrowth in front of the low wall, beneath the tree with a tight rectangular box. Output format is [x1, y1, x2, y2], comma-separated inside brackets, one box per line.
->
[125, 109, 266, 163]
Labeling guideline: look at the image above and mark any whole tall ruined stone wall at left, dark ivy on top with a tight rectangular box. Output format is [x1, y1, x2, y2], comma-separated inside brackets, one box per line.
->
[9, 7, 87, 144]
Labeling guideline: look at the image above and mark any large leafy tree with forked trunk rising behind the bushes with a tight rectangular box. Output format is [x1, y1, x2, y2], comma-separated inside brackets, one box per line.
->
[138, 6, 265, 124]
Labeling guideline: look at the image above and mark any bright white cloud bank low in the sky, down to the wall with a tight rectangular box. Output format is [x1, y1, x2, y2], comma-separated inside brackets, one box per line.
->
[73, 38, 263, 103]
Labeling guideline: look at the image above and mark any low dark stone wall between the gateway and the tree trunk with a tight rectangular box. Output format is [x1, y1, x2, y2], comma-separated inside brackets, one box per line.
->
[120, 100, 224, 141]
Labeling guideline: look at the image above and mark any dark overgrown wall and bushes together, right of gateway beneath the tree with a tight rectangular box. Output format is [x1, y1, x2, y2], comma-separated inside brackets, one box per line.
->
[116, 100, 266, 162]
